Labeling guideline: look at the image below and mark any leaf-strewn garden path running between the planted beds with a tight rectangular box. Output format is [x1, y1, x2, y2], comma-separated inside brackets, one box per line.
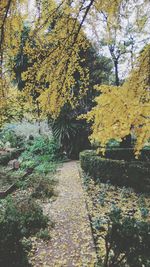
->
[30, 161, 96, 267]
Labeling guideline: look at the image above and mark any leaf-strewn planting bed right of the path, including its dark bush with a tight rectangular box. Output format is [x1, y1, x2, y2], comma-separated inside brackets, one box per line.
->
[83, 174, 150, 267]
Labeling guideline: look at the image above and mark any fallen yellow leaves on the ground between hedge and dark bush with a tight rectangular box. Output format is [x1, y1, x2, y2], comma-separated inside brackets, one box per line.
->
[83, 178, 150, 263]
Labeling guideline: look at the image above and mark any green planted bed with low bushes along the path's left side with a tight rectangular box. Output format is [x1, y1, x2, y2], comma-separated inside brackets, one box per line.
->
[0, 130, 60, 267]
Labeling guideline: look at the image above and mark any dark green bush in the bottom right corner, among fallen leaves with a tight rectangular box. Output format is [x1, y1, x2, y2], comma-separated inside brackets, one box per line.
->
[93, 207, 150, 267]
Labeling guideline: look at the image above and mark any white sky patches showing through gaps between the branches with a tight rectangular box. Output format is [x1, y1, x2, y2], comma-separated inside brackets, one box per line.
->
[28, 0, 150, 79]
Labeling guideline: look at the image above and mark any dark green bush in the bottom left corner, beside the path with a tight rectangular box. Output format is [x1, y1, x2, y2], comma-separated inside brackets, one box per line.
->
[0, 198, 48, 267]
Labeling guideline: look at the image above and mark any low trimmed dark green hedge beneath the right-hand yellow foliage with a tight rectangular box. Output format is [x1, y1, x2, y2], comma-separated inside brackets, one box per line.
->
[80, 149, 150, 192]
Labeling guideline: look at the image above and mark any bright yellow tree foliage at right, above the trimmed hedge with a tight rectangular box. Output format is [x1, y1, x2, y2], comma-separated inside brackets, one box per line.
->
[83, 45, 150, 155]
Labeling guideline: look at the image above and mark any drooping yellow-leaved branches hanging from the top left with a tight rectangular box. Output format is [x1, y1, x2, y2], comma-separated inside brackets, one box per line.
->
[0, 0, 127, 121]
